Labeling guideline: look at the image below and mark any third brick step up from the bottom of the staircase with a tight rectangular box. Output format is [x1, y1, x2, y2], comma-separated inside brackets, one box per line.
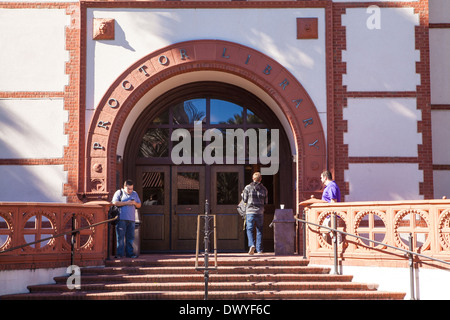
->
[54, 273, 353, 284]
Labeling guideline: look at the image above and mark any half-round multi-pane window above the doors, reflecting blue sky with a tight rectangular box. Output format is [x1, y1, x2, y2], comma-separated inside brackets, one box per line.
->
[138, 98, 272, 161]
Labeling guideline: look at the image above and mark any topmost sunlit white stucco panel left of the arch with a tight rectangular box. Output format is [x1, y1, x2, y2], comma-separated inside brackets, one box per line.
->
[0, 9, 70, 91]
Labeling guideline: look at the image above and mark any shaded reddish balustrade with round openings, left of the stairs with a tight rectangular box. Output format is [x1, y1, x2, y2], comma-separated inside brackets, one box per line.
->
[0, 202, 109, 270]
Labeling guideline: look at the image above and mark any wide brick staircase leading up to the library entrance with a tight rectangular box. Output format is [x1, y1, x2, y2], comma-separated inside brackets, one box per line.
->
[0, 253, 405, 300]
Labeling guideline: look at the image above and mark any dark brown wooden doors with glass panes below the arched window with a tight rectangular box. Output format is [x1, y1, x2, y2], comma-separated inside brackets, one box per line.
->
[136, 165, 246, 252]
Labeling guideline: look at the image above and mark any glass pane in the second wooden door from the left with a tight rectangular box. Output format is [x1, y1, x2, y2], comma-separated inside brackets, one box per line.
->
[177, 172, 200, 205]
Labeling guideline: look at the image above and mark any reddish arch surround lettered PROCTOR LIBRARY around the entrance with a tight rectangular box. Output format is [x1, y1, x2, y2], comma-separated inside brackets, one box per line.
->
[84, 40, 326, 251]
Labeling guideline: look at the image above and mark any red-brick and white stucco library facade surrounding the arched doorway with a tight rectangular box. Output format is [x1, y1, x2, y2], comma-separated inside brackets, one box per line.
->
[0, 0, 450, 251]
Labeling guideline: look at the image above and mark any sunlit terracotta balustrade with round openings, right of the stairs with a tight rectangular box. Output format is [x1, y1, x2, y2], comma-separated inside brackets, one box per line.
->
[299, 200, 450, 269]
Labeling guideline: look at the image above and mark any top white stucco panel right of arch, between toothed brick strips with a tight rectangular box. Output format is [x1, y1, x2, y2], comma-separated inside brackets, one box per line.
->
[342, 8, 420, 91]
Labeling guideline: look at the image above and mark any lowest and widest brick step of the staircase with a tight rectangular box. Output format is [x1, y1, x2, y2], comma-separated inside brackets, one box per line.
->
[2, 290, 405, 300]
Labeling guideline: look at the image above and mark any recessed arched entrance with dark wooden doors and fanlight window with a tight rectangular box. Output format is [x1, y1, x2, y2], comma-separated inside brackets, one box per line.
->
[124, 82, 295, 252]
